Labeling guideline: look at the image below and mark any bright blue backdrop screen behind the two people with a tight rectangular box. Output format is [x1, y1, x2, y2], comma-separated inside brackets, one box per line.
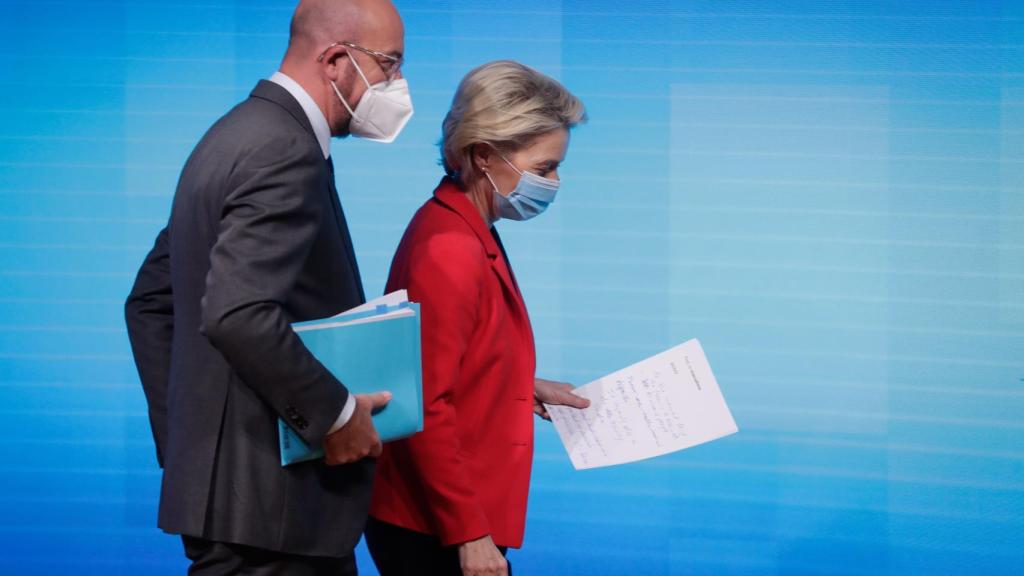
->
[0, 0, 1024, 575]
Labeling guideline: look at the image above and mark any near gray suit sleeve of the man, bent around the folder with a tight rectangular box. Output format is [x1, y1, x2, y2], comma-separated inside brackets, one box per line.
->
[202, 138, 348, 444]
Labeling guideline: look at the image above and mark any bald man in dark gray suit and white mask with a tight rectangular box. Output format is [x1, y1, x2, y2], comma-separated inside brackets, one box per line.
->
[119, 0, 412, 575]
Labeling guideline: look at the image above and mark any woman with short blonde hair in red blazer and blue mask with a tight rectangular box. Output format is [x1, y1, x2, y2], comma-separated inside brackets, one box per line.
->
[367, 60, 588, 576]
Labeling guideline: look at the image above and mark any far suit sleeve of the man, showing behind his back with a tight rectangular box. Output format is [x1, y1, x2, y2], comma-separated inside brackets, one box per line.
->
[125, 228, 174, 467]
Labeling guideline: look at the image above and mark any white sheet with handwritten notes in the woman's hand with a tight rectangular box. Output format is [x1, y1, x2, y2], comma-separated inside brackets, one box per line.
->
[546, 339, 738, 469]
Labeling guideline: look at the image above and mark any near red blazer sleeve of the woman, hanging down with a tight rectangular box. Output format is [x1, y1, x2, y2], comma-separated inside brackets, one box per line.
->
[389, 228, 490, 546]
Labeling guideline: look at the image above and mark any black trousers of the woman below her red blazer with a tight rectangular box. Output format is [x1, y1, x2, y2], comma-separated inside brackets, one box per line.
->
[366, 517, 512, 576]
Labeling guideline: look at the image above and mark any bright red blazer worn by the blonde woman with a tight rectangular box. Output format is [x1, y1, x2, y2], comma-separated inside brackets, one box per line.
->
[370, 178, 537, 547]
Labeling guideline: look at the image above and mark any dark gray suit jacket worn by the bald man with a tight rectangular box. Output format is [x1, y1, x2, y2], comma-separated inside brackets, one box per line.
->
[125, 81, 374, 557]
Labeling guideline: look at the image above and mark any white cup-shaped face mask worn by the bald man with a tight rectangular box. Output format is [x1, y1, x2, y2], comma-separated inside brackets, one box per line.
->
[331, 53, 413, 143]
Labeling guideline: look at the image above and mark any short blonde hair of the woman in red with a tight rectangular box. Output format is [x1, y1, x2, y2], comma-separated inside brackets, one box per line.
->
[438, 60, 587, 183]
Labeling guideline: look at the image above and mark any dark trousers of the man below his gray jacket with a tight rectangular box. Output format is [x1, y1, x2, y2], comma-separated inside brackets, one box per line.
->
[181, 536, 357, 576]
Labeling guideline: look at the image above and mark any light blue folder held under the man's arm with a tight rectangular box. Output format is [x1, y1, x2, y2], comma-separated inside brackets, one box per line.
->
[278, 293, 423, 466]
